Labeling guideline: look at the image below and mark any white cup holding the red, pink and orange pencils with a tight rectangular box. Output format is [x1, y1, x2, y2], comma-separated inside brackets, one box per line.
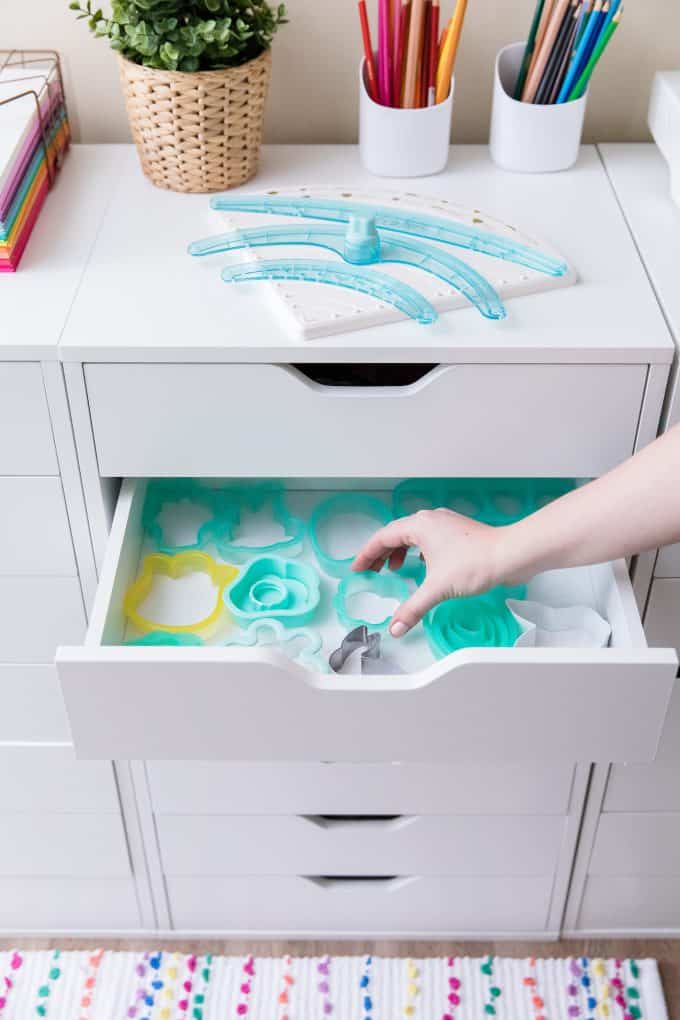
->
[359, 59, 454, 177]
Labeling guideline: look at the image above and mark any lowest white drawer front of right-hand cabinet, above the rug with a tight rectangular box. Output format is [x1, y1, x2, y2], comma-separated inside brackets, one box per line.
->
[578, 875, 680, 935]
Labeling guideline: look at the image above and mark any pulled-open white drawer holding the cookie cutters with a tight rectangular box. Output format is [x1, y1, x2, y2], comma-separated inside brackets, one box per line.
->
[57, 479, 677, 762]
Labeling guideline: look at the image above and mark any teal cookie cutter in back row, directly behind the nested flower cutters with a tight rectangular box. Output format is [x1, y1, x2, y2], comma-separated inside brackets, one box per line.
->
[202, 485, 306, 563]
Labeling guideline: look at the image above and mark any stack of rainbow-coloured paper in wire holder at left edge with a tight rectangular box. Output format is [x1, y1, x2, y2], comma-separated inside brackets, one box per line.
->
[0, 51, 70, 272]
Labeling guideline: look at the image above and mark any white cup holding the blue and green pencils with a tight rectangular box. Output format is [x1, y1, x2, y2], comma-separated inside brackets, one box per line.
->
[489, 43, 587, 173]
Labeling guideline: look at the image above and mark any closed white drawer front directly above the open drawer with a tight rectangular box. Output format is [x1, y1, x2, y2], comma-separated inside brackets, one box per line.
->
[86, 364, 646, 477]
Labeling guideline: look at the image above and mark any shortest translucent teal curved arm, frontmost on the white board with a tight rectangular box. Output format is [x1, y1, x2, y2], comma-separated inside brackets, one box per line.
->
[222, 258, 437, 325]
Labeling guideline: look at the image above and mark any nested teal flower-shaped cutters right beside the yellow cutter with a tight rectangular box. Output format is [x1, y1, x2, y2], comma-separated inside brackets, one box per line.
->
[224, 556, 321, 627]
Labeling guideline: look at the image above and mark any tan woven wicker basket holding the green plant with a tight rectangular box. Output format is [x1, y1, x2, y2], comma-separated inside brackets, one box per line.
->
[118, 50, 271, 192]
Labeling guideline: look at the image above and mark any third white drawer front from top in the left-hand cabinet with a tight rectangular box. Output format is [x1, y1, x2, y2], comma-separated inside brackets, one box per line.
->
[0, 576, 86, 663]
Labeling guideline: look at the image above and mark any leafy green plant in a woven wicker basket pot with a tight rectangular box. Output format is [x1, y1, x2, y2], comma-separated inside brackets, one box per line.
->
[69, 0, 285, 192]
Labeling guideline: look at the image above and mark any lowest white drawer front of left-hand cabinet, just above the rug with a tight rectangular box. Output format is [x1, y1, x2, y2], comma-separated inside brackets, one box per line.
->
[0, 877, 141, 936]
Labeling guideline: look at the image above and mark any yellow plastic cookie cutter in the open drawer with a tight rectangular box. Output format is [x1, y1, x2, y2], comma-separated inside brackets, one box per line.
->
[122, 550, 239, 633]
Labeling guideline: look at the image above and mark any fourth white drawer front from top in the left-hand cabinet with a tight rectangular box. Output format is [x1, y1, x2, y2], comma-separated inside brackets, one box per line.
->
[0, 664, 70, 744]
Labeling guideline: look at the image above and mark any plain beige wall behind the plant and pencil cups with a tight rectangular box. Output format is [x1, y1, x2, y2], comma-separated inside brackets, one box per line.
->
[0, 0, 680, 142]
